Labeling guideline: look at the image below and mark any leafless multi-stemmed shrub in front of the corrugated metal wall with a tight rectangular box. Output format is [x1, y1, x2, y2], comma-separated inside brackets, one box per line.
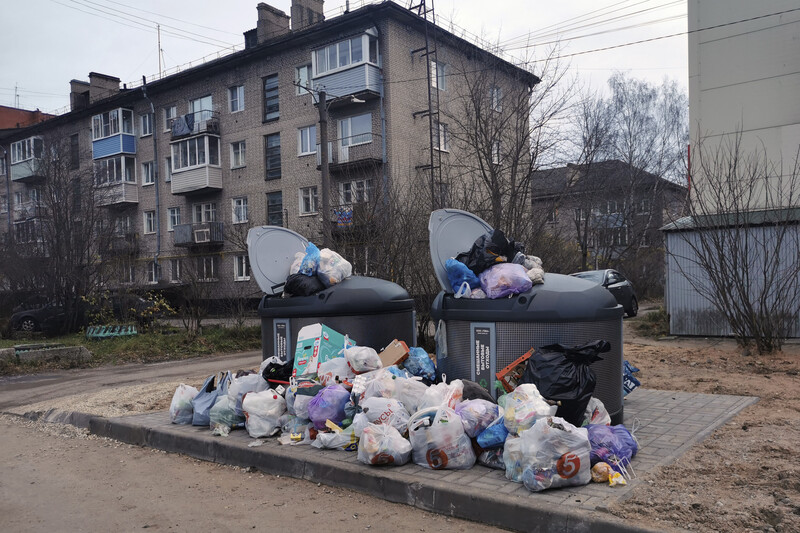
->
[668, 133, 800, 354]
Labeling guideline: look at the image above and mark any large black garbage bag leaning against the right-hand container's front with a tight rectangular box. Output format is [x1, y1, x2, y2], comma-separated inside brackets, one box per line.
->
[520, 340, 611, 427]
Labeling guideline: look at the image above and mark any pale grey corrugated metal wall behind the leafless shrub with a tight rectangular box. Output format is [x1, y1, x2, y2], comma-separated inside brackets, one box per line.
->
[665, 226, 800, 337]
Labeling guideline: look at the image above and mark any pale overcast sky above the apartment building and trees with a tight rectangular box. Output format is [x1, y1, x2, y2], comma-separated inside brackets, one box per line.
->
[0, 0, 687, 112]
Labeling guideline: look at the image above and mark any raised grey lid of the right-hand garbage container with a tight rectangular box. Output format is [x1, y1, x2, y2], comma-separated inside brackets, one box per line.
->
[428, 209, 494, 293]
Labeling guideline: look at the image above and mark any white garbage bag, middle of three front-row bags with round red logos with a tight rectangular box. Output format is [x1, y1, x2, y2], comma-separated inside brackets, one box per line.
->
[408, 405, 476, 470]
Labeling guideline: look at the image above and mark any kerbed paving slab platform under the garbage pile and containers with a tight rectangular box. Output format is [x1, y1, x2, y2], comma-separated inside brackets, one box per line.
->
[28, 389, 758, 532]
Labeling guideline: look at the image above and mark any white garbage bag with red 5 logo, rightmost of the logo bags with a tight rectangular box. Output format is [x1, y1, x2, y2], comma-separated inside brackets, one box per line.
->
[520, 416, 592, 492]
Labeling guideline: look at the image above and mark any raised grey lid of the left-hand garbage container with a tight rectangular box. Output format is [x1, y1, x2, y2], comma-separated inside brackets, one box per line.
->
[247, 222, 308, 294]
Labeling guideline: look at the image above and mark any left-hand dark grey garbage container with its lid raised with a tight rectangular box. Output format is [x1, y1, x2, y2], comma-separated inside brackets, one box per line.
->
[247, 226, 417, 361]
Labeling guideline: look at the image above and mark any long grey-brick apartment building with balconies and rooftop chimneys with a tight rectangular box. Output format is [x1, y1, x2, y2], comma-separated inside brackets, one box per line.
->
[0, 0, 538, 306]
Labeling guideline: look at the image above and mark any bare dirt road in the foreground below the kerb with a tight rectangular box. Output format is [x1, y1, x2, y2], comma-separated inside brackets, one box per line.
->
[0, 415, 501, 533]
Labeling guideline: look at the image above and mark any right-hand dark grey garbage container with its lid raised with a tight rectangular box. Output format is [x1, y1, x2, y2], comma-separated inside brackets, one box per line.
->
[428, 209, 623, 424]
